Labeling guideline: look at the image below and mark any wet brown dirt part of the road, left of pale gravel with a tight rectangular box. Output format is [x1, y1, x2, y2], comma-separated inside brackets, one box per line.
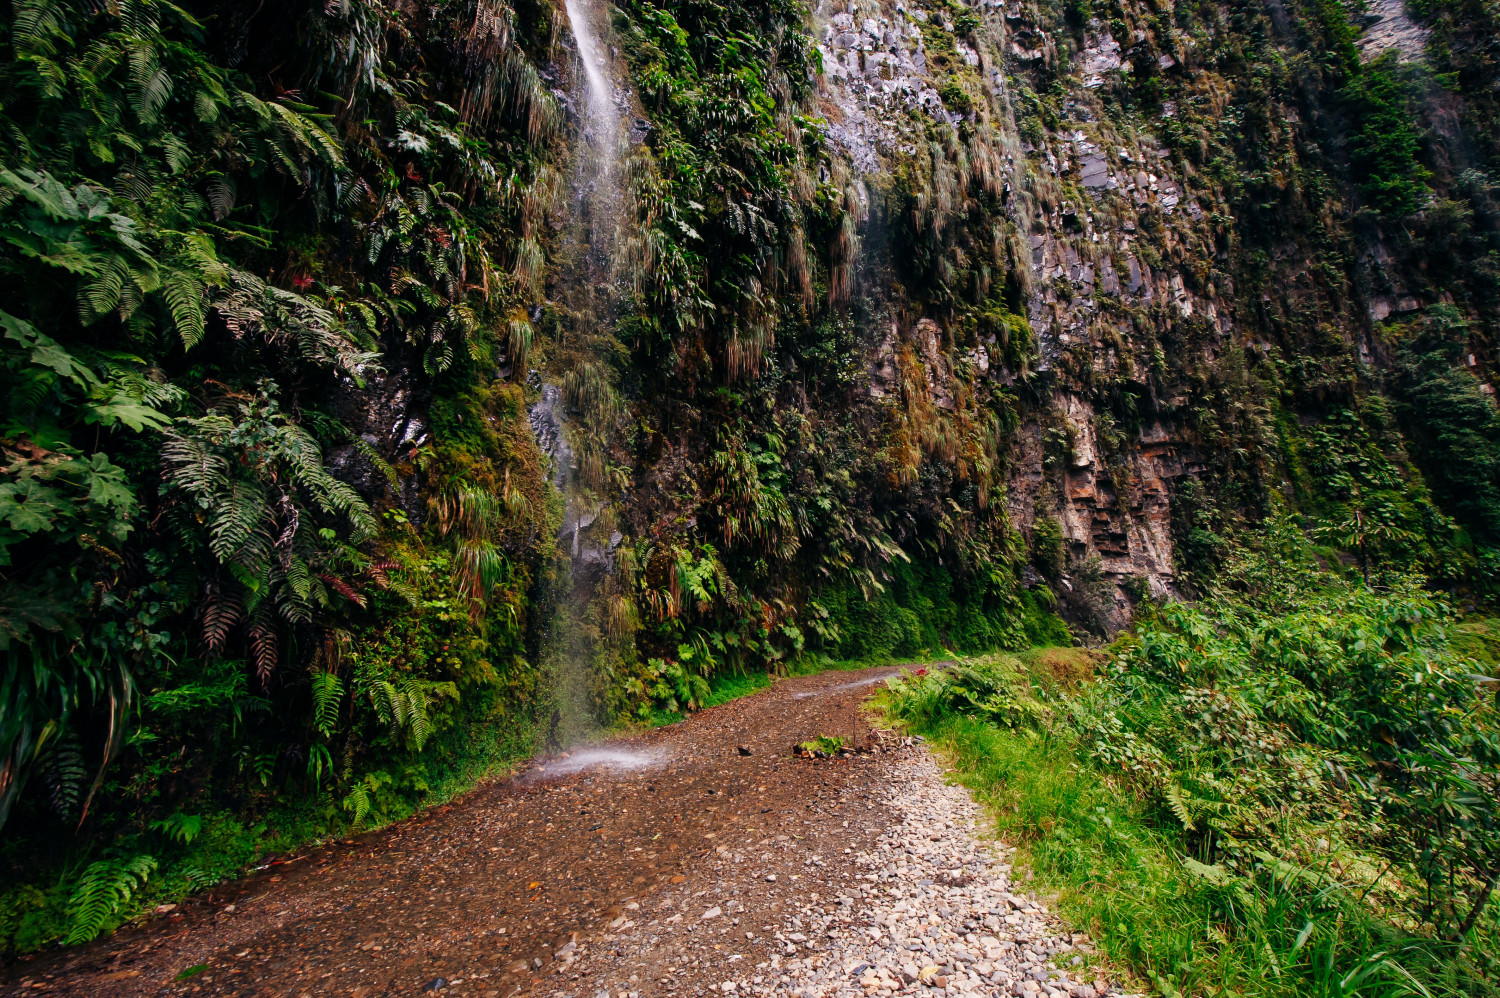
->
[0, 668, 936, 998]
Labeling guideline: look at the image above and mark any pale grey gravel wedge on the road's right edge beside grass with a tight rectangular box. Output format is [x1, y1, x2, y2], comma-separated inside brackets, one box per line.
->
[702, 750, 1122, 998]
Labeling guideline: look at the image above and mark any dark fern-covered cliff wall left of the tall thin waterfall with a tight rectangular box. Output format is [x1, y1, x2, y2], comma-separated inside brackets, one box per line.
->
[0, 0, 560, 953]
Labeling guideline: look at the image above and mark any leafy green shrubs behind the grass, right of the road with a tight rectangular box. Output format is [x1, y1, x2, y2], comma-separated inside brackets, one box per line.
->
[1083, 552, 1500, 938]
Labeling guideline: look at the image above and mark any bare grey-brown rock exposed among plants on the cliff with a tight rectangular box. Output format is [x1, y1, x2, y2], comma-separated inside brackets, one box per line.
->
[818, 2, 1235, 606]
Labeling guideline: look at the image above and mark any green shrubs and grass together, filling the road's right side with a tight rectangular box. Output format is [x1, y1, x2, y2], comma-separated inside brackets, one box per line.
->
[887, 531, 1500, 995]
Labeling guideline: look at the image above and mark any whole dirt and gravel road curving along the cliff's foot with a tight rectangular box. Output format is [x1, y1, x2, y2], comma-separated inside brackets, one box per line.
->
[0, 668, 1115, 998]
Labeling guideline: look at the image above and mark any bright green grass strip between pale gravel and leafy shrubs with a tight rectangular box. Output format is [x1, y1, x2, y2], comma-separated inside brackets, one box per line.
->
[882, 693, 1493, 998]
